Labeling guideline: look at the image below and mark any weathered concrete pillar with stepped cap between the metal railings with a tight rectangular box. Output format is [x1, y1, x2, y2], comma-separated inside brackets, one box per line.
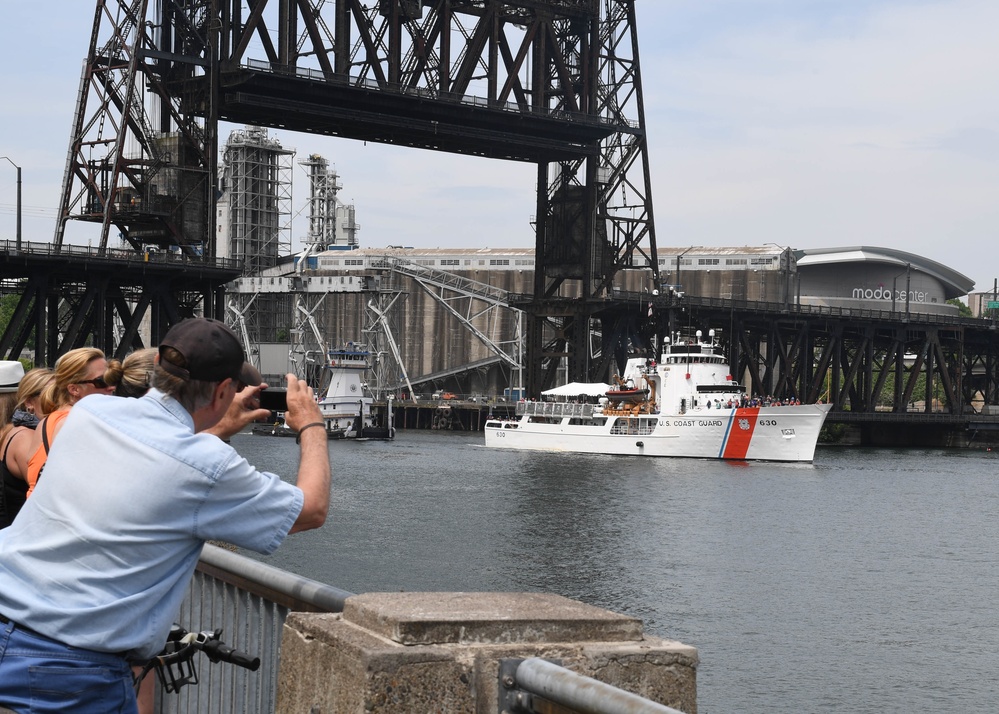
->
[277, 593, 697, 714]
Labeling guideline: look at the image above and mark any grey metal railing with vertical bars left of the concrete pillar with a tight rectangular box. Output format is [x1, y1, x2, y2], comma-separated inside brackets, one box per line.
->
[156, 545, 353, 714]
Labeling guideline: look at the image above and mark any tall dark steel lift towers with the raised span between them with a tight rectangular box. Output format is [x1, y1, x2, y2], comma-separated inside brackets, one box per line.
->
[48, 0, 658, 382]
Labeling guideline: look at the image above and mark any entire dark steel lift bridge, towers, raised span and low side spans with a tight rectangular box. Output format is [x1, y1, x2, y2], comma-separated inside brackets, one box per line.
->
[9, 0, 999, 426]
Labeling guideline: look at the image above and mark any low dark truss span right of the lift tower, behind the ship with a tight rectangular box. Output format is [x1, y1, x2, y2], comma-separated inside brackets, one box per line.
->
[640, 294, 999, 444]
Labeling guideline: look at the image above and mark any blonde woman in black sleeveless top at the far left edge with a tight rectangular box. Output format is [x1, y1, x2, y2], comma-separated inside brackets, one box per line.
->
[0, 367, 52, 528]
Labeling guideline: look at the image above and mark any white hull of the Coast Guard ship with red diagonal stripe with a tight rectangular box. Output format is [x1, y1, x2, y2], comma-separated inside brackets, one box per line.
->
[485, 404, 830, 462]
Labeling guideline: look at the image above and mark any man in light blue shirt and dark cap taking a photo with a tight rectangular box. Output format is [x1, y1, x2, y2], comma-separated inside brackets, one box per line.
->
[0, 318, 330, 713]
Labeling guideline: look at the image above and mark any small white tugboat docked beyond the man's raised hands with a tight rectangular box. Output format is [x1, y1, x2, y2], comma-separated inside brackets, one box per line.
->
[319, 342, 395, 439]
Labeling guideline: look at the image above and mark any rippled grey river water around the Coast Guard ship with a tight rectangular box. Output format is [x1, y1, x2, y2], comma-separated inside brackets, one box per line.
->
[233, 431, 999, 714]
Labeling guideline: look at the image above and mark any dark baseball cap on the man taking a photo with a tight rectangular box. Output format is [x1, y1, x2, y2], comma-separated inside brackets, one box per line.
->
[159, 317, 263, 387]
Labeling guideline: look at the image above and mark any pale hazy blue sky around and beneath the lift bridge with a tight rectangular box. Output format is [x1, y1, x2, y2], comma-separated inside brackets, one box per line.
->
[0, 0, 999, 290]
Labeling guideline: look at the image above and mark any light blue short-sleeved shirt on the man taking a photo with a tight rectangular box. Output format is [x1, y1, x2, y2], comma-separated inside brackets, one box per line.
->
[0, 390, 304, 659]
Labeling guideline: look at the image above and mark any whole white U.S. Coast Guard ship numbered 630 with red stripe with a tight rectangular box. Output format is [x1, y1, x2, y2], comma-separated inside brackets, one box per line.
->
[485, 330, 831, 461]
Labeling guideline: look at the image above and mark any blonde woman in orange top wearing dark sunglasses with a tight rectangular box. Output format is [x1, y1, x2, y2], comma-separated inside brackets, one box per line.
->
[27, 347, 114, 497]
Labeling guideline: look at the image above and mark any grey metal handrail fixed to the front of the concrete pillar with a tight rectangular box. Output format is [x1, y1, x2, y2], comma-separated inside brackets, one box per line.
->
[499, 657, 683, 714]
